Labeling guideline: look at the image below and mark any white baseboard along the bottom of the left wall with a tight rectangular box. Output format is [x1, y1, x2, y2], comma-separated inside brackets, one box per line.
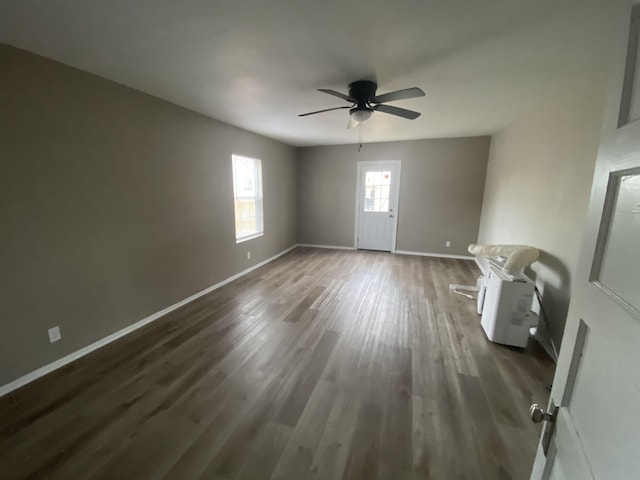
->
[0, 245, 298, 397]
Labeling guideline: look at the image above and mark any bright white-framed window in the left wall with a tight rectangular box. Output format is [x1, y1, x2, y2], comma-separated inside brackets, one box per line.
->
[232, 155, 264, 243]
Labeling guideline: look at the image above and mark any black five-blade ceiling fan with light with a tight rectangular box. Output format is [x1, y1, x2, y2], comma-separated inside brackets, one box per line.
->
[298, 80, 424, 128]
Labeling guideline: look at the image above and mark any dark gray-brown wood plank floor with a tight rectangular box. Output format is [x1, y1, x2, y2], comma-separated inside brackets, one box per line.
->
[0, 248, 554, 480]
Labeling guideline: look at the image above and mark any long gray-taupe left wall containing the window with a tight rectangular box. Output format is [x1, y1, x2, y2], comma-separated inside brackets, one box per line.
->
[0, 45, 296, 385]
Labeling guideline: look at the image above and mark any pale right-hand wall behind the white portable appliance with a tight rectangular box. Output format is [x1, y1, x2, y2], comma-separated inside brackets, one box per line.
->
[479, 74, 606, 346]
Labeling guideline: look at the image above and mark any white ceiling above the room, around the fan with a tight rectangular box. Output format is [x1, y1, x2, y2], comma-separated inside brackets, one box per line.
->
[0, 0, 612, 146]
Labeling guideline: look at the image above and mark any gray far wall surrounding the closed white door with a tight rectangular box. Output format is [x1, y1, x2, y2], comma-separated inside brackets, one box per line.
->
[298, 137, 489, 255]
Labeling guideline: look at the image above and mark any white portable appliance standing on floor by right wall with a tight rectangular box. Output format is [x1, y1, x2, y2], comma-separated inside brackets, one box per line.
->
[478, 263, 538, 347]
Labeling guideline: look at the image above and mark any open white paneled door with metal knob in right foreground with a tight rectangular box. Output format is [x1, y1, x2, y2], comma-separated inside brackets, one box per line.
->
[531, 1, 640, 480]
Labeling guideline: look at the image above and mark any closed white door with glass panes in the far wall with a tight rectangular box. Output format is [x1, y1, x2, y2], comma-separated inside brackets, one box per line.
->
[356, 161, 400, 252]
